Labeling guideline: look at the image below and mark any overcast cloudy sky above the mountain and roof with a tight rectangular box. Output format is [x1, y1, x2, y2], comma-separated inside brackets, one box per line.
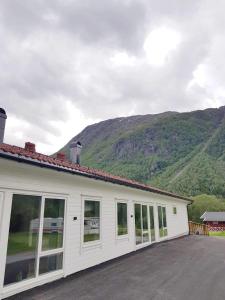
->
[0, 0, 225, 153]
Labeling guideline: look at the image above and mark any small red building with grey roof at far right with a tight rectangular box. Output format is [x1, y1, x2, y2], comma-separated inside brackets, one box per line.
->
[200, 211, 225, 231]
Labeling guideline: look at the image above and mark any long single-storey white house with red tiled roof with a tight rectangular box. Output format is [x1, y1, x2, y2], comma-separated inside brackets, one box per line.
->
[0, 108, 191, 299]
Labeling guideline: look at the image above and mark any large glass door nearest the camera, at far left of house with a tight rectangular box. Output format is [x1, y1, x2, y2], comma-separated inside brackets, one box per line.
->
[4, 194, 65, 285]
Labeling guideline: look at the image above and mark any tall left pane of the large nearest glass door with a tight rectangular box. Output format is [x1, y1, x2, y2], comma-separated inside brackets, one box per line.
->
[4, 194, 41, 285]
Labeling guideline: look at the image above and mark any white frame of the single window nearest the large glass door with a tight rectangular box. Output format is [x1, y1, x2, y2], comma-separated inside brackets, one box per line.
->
[80, 195, 102, 249]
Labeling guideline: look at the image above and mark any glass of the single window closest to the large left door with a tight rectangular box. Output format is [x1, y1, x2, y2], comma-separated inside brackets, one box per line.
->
[84, 201, 100, 242]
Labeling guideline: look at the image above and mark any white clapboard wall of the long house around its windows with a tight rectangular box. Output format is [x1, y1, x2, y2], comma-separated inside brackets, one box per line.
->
[0, 159, 188, 298]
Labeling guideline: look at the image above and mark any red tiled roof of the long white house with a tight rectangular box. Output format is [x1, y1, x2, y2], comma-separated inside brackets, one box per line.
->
[0, 144, 192, 202]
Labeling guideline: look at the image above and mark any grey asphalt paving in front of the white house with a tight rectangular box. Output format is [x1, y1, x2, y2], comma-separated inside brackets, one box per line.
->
[9, 236, 225, 300]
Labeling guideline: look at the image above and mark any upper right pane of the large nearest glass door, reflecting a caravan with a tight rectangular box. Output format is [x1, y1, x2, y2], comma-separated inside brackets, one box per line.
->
[42, 198, 65, 251]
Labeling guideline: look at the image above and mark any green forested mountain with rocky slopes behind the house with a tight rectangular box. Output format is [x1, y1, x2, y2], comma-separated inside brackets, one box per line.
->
[57, 106, 225, 197]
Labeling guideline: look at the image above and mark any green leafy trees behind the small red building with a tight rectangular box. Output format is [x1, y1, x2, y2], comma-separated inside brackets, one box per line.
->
[188, 195, 225, 223]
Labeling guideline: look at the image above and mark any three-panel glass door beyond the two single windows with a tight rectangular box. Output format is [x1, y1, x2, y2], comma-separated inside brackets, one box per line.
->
[134, 203, 155, 245]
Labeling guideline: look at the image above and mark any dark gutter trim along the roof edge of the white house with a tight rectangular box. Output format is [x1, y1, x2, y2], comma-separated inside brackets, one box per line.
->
[0, 152, 193, 203]
